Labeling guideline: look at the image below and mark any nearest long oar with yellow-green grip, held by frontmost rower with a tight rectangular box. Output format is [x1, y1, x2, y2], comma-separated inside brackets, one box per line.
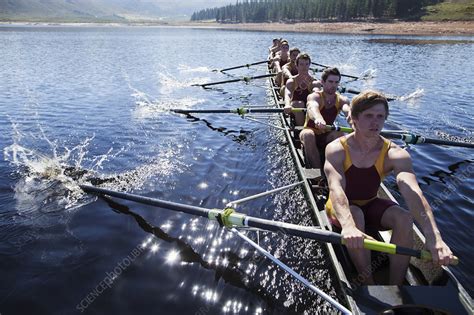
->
[79, 185, 459, 265]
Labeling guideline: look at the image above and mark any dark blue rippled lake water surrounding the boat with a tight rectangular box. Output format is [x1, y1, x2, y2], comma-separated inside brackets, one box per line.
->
[0, 26, 474, 315]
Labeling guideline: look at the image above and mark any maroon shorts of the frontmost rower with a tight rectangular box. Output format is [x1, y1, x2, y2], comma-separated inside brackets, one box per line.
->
[329, 198, 398, 231]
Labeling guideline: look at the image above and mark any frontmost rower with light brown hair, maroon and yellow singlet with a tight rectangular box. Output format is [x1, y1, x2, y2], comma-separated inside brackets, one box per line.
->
[324, 91, 453, 285]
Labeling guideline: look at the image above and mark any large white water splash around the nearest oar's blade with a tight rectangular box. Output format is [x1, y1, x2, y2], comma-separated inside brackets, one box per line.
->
[3, 123, 186, 217]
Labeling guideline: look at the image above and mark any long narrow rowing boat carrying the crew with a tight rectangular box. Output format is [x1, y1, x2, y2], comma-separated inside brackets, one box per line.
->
[269, 66, 473, 314]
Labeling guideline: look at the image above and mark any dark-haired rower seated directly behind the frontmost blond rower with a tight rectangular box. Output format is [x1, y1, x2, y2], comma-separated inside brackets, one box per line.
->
[300, 68, 350, 168]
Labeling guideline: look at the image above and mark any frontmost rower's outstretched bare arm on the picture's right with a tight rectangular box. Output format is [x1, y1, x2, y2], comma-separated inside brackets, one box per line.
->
[389, 146, 441, 242]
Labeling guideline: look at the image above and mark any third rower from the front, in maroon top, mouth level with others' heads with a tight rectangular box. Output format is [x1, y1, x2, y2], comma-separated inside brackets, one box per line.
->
[284, 53, 321, 126]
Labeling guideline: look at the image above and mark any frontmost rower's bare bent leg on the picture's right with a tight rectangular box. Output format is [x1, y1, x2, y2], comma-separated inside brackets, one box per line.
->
[380, 206, 413, 285]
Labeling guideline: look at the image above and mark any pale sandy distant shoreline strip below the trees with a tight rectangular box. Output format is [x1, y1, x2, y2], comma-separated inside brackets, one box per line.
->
[0, 21, 474, 36]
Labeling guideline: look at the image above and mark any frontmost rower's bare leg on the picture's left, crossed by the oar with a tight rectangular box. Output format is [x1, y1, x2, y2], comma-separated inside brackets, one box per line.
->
[347, 206, 375, 285]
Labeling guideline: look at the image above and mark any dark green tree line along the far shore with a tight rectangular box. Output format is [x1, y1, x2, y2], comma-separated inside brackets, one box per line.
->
[191, 0, 443, 23]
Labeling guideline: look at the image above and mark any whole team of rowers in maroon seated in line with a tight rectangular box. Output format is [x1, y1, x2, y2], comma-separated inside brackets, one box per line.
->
[269, 38, 453, 285]
